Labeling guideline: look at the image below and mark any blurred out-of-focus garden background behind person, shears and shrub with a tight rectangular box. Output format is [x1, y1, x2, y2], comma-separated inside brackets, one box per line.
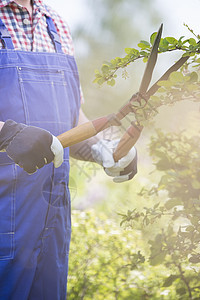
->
[46, 0, 200, 300]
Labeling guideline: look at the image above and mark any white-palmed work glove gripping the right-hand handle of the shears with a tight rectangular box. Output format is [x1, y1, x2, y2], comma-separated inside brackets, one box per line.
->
[91, 139, 137, 183]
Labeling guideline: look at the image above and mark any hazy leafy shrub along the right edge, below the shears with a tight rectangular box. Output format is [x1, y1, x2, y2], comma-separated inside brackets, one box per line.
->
[121, 130, 200, 299]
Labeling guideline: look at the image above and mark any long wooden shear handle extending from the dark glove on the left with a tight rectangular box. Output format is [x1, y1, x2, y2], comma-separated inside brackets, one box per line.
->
[57, 114, 121, 148]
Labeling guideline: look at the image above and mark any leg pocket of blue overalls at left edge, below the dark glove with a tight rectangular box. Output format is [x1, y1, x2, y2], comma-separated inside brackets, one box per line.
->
[0, 159, 16, 260]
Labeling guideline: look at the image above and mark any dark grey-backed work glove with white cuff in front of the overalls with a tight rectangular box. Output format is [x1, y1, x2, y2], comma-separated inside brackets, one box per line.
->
[0, 120, 63, 174]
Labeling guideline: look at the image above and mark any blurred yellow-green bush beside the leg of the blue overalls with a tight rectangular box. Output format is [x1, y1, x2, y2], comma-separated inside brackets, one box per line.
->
[68, 210, 176, 300]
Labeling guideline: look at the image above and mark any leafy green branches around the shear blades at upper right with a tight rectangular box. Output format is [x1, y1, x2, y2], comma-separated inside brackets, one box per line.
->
[94, 29, 200, 130]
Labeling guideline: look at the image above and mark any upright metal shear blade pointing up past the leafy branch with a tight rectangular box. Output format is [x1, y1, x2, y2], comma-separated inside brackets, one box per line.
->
[139, 24, 163, 95]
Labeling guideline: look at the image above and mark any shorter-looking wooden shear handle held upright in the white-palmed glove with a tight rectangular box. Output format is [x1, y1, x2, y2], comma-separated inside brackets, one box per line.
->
[113, 123, 143, 162]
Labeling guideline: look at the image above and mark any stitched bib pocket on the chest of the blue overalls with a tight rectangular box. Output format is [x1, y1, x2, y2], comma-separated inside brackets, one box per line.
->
[18, 66, 72, 135]
